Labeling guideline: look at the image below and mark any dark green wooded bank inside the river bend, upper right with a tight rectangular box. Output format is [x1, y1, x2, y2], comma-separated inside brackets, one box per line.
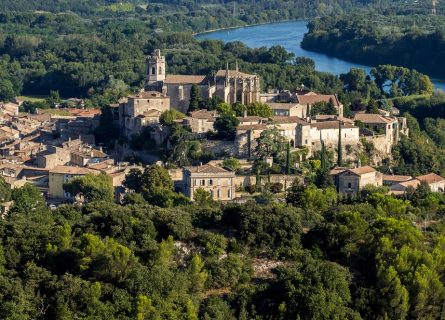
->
[302, 13, 445, 77]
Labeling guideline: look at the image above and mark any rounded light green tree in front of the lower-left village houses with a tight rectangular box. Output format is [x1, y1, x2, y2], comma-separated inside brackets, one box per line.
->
[63, 174, 114, 202]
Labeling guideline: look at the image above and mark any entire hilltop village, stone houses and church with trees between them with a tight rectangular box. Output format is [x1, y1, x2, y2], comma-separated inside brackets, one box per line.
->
[0, 50, 445, 212]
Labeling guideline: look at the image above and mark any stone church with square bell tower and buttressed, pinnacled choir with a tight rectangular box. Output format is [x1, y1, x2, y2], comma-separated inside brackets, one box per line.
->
[145, 49, 261, 113]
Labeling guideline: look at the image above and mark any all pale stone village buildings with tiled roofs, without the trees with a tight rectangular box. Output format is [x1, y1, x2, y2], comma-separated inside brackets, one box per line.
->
[0, 50, 438, 210]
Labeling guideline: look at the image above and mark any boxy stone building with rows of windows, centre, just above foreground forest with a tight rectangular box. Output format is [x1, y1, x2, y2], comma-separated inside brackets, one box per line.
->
[183, 164, 235, 201]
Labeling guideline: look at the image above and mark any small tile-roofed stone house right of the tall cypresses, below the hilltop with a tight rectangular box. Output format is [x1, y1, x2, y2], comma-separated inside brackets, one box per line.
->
[331, 166, 383, 197]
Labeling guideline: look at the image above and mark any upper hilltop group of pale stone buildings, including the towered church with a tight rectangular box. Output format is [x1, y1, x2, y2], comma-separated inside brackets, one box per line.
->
[111, 50, 408, 164]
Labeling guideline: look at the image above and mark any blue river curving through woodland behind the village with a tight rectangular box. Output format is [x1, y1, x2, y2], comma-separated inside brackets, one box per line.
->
[196, 20, 445, 90]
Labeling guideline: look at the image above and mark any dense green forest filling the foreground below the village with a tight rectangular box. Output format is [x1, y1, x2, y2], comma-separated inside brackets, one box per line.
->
[0, 165, 445, 320]
